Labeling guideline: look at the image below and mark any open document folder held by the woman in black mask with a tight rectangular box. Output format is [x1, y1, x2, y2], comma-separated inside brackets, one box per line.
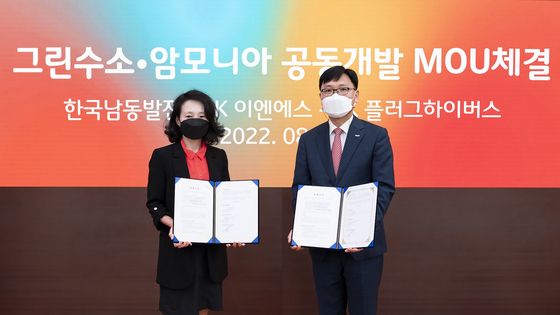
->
[173, 177, 259, 243]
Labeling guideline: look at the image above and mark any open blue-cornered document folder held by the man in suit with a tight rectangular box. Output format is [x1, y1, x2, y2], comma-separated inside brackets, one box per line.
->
[292, 182, 378, 249]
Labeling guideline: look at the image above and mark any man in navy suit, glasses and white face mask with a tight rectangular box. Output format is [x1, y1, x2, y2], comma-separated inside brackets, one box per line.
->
[288, 66, 395, 315]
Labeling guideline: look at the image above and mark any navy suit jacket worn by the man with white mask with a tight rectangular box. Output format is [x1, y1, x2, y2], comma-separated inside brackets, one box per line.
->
[292, 117, 395, 260]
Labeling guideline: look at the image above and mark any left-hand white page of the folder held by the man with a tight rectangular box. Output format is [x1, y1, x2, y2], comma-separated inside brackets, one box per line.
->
[292, 186, 341, 248]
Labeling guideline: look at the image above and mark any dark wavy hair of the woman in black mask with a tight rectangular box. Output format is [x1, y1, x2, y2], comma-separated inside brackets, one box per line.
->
[165, 90, 225, 145]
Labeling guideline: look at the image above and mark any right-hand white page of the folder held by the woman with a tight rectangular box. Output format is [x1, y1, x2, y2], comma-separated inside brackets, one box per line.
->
[216, 180, 259, 243]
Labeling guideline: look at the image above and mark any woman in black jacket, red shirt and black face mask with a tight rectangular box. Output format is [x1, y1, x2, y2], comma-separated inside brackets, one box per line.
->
[146, 90, 244, 315]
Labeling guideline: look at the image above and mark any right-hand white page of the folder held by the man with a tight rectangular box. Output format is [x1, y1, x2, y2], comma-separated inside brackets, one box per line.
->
[340, 183, 377, 248]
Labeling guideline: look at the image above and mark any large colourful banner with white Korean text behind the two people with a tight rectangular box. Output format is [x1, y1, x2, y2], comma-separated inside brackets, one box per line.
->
[0, 0, 560, 187]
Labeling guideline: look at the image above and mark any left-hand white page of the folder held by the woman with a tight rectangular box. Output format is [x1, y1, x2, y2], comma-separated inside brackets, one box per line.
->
[173, 178, 214, 243]
